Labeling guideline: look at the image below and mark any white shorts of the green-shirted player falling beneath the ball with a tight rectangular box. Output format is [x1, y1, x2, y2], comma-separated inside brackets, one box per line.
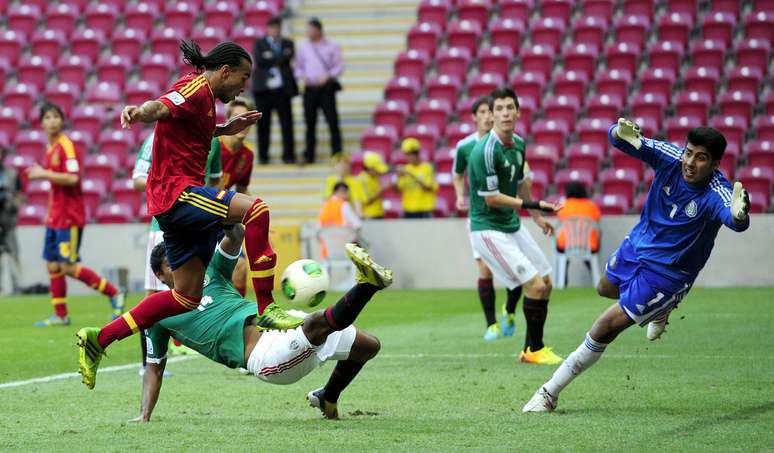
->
[247, 310, 357, 385]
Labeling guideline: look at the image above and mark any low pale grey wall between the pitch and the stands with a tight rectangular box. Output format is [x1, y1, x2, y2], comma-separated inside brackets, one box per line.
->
[10, 214, 774, 294]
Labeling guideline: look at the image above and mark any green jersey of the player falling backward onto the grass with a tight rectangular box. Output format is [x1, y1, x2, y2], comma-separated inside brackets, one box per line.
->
[145, 248, 258, 368]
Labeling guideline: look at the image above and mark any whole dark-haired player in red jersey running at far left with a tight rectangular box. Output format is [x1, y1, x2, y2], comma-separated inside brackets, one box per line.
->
[27, 103, 124, 327]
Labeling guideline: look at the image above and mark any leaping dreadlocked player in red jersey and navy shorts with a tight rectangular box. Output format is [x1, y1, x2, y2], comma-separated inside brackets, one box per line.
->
[76, 41, 303, 388]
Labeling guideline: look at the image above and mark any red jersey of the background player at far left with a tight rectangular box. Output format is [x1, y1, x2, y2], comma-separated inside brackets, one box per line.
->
[43, 134, 86, 228]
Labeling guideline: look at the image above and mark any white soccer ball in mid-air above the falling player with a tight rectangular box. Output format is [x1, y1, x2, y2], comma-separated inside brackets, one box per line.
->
[280, 260, 330, 308]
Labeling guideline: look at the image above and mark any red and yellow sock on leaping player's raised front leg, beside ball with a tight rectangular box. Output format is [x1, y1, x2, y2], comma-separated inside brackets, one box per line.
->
[242, 198, 277, 314]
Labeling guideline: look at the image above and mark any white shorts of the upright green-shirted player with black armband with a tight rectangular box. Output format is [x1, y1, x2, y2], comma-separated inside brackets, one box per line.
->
[470, 228, 551, 289]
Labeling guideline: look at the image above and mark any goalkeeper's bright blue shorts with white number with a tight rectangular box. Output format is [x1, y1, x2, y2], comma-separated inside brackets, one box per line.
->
[605, 237, 693, 326]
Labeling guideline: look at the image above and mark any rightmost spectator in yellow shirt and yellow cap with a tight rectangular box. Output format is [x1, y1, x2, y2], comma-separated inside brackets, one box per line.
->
[397, 138, 438, 219]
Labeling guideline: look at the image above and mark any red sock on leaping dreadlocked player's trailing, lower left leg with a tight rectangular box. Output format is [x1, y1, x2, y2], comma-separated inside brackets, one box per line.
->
[98, 289, 201, 348]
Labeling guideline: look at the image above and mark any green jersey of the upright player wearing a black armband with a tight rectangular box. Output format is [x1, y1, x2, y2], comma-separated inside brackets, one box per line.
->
[468, 131, 526, 233]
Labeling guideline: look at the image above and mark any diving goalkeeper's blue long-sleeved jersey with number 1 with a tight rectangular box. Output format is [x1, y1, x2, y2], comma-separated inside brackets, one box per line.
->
[608, 125, 750, 282]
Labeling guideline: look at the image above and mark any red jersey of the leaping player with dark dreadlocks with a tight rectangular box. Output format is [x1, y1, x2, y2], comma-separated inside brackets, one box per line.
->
[145, 74, 215, 215]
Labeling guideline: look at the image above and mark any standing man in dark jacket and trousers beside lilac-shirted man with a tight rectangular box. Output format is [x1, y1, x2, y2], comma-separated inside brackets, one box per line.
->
[253, 17, 298, 164]
